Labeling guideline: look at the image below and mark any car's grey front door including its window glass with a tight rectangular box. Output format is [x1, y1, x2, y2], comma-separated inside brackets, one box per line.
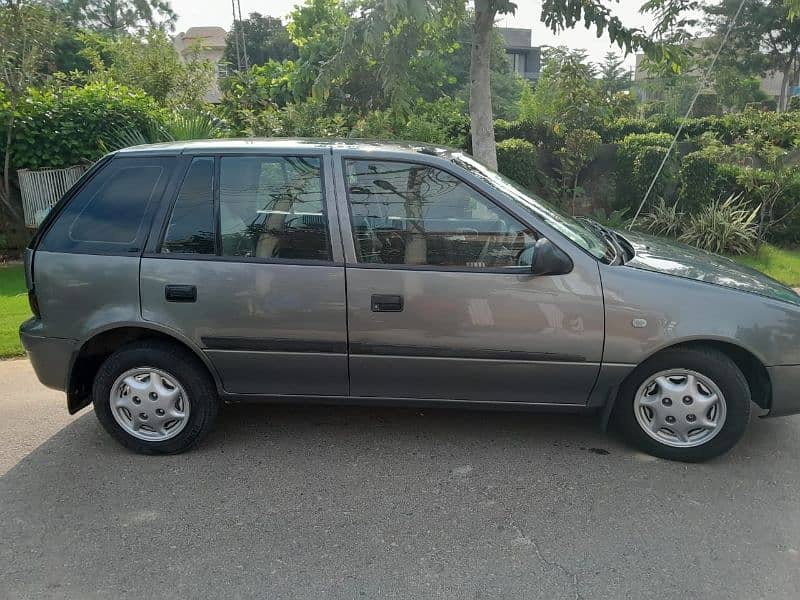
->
[334, 151, 604, 404]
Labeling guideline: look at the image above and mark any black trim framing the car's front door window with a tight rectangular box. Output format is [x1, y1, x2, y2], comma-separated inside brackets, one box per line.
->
[339, 153, 552, 277]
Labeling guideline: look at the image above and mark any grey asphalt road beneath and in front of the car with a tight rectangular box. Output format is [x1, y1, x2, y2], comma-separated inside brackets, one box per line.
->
[0, 360, 800, 600]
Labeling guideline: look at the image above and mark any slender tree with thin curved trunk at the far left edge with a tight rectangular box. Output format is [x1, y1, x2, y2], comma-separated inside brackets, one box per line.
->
[0, 0, 58, 221]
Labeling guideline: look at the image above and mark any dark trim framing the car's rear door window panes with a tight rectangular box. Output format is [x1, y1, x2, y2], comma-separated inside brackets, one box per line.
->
[152, 149, 344, 267]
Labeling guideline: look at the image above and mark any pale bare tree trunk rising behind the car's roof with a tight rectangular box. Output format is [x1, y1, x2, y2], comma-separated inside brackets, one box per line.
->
[469, 0, 497, 169]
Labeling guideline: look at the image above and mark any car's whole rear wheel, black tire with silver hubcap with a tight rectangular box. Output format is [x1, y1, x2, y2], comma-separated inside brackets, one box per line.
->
[92, 342, 218, 454]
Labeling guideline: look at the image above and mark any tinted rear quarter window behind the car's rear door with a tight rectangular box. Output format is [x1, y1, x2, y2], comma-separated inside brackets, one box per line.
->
[39, 157, 175, 254]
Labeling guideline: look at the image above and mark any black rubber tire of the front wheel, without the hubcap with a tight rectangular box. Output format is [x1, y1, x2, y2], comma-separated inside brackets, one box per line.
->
[612, 347, 750, 462]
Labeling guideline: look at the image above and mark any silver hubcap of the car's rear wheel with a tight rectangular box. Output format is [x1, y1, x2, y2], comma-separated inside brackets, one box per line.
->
[109, 367, 189, 442]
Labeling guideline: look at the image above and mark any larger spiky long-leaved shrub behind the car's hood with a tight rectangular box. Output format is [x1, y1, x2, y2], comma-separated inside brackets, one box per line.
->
[679, 195, 761, 254]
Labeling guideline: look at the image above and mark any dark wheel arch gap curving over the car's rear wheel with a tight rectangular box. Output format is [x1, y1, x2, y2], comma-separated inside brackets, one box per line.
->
[67, 322, 222, 414]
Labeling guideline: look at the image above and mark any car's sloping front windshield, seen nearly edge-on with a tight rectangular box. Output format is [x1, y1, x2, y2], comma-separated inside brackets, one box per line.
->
[450, 153, 616, 262]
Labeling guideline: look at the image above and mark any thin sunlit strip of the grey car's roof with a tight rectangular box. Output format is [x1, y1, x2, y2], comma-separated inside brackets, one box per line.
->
[118, 138, 458, 157]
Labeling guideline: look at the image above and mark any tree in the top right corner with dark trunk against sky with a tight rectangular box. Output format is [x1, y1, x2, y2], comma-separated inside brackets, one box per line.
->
[705, 0, 800, 110]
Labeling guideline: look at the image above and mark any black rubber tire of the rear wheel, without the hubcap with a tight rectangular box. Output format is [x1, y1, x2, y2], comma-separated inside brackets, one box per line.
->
[92, 341, 219, 454]
